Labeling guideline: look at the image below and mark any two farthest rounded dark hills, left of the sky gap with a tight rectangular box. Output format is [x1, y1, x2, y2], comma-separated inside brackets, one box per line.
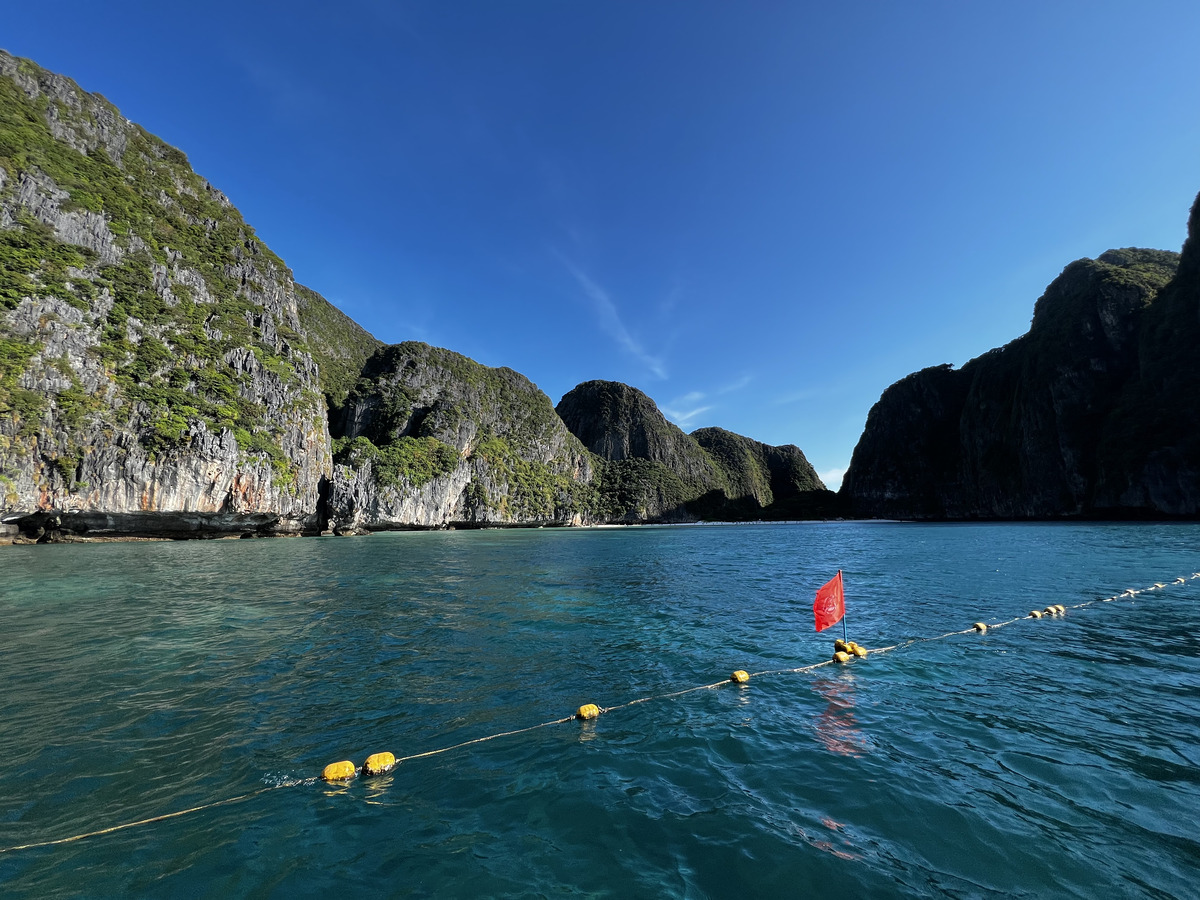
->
[557, 382, 833, 522]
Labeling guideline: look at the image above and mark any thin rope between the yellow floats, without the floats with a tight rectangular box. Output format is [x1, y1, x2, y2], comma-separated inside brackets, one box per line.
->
[0, 572, 1200, 854]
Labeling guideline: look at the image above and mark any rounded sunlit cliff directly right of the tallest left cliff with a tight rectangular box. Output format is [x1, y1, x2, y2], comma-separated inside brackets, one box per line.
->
[329, 342, 595, 528]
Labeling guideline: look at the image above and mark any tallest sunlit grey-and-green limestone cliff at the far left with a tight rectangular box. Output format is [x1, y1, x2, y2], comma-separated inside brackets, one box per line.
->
[0, 52, 330, 533]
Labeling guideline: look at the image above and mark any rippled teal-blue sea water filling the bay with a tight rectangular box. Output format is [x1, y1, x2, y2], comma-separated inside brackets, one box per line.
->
[0, 523, 1200, 900]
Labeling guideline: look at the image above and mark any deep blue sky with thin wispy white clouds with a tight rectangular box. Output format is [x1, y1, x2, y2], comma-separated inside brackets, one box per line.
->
[0, 0, 1200, 487]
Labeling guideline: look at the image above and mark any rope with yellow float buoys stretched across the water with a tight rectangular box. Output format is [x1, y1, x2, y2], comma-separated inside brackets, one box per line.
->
[0, 572, 1200, 854]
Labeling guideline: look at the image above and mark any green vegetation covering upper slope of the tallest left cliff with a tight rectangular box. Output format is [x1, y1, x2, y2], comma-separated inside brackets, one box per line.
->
[0, 52, 316, 470]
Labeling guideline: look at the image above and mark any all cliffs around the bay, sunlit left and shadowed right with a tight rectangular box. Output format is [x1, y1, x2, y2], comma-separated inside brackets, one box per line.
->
[0, 52, 1200, 541]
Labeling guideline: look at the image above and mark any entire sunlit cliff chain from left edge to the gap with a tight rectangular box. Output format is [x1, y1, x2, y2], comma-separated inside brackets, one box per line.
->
[0, 52, 827, 542]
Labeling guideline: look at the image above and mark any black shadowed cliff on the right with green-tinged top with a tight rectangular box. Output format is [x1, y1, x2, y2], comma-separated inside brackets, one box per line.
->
[841, 232, 1185, 518]
